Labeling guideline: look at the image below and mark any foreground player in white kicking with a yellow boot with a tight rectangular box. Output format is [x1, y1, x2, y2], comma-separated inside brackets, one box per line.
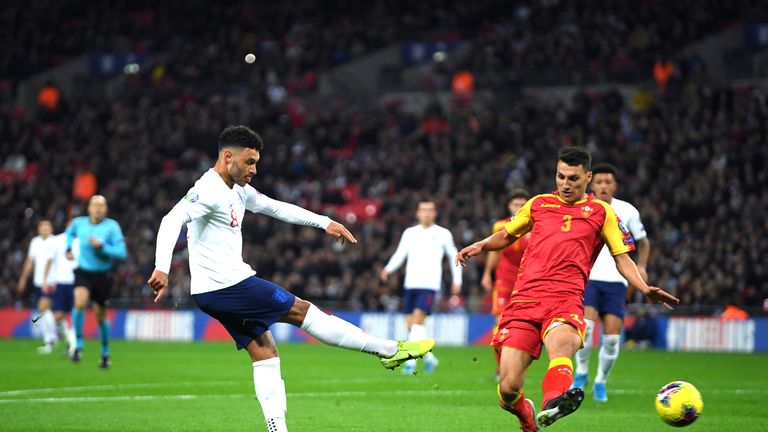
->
[148, 126, 435, 432]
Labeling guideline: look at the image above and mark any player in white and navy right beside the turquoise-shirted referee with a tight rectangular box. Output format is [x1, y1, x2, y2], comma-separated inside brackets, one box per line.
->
[46, 232, 80, 355]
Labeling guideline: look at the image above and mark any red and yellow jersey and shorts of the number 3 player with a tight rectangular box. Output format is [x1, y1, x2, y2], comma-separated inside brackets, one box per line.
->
[493, 192, 634, 358]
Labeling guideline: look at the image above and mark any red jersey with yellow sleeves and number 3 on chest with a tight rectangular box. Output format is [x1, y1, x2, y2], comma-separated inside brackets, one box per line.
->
[504, 192, 634, 302]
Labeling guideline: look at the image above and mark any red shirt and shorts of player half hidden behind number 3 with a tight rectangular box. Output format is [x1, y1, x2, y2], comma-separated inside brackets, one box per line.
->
[491, 218, 530, 316]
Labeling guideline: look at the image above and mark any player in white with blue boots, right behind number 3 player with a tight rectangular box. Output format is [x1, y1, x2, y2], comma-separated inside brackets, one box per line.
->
[573, 163, 651, 402]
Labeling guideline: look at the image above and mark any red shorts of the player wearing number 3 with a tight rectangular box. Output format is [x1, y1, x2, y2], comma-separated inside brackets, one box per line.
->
[491, 296, 587, 358]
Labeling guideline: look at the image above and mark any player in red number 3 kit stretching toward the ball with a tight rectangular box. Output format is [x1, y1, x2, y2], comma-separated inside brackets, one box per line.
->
[456, 147, 678, 432]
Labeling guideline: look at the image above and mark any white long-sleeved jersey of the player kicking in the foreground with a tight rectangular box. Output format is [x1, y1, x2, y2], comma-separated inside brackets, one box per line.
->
[155, 169, 331, 295]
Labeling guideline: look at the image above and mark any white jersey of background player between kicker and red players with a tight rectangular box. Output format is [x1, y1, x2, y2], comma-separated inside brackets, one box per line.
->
[384, 225, 462, 291]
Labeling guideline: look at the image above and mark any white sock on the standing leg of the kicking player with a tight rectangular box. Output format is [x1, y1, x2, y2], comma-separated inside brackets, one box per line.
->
[253, 357, 288, 432]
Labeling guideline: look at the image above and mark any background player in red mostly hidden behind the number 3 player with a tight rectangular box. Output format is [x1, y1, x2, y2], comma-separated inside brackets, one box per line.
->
[480, 189, 531, 379]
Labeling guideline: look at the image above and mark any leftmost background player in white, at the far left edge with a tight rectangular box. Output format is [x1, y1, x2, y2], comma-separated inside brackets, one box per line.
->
[16, 220, 59, 354]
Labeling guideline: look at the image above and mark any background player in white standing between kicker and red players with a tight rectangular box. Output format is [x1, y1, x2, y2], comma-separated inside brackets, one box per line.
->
[380, 198, 462, 374]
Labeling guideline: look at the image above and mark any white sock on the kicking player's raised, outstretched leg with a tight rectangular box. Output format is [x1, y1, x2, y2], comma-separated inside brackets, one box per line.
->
[301, 305, 397, 357]
